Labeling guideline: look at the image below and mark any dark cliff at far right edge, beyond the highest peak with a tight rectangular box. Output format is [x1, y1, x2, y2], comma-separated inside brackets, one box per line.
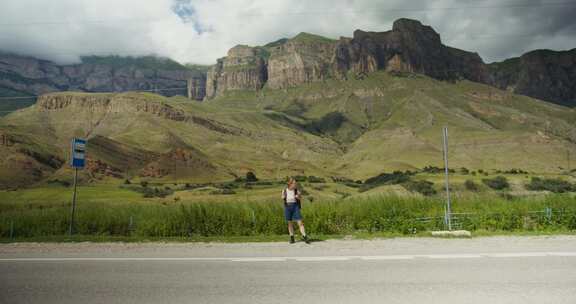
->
[489, 49, 576, 107]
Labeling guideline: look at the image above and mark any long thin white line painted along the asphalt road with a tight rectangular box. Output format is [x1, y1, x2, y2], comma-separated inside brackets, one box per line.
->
[0, 252, 576, 263]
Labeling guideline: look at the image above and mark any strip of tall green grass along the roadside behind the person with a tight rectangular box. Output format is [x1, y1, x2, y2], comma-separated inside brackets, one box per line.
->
[0, 195, 576, 238]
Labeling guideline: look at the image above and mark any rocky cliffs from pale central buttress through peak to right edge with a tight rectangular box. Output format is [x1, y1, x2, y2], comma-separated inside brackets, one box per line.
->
[206, 19, 576, 106]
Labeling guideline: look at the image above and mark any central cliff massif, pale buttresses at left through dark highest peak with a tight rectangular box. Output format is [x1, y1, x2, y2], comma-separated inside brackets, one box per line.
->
[207, 19, 488, 98]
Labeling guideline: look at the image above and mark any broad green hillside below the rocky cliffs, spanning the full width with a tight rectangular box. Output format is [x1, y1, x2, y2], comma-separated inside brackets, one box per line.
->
[0, 71, 576, 187]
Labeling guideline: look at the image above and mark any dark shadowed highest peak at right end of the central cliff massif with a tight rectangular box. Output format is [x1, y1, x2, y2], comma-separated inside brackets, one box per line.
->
[334, 19, 487, 82]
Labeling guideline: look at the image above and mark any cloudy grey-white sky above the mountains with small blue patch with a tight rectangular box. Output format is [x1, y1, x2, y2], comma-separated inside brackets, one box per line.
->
[0, 0, 576, 64]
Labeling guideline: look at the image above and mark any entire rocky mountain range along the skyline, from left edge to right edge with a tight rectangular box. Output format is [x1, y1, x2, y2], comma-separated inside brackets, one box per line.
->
[0, 19, 576, 111]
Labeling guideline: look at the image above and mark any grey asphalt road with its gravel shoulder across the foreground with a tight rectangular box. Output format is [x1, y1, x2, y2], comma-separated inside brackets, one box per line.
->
[0, 236, 576, 304]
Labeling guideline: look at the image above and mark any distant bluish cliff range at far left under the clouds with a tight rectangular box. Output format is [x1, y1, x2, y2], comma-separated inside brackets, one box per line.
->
[0, 53, 206, 100]
